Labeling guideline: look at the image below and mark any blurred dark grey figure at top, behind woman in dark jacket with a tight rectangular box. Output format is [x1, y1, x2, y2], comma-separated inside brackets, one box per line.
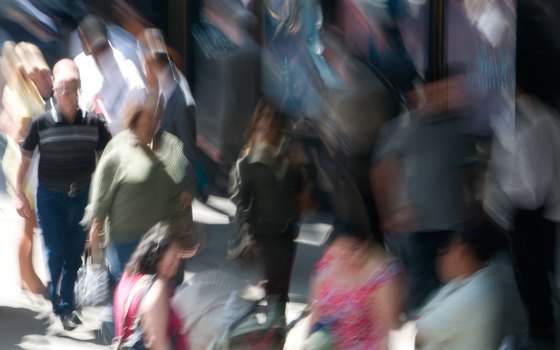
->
[193, 0, 261, 191]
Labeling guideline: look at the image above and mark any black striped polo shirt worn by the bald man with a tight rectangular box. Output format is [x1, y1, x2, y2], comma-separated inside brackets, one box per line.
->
[21, 109, 111, 189]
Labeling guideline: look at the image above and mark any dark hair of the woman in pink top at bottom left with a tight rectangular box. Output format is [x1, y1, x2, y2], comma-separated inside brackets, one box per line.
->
[125, 222, 180, 275]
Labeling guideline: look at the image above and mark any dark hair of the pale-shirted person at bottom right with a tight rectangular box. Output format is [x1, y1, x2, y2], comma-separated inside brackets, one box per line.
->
[455, 220, 505, 261]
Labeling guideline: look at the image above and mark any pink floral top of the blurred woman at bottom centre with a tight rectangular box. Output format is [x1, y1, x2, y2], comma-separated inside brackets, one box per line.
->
[314, 254, 401, 350]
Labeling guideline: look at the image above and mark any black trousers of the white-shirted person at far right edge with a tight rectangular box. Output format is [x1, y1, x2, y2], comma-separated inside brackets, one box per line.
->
[510, 211, 555, 339]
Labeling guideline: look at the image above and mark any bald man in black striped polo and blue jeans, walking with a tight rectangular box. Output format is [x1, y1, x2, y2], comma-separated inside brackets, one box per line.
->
[14, 59, 111, 330]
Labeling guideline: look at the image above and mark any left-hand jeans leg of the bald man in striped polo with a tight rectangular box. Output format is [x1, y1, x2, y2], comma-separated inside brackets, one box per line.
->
[37, 186, 66, 316]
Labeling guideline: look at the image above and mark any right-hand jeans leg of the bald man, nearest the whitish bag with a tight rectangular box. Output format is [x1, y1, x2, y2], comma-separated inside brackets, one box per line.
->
[60, 192, 88, 314]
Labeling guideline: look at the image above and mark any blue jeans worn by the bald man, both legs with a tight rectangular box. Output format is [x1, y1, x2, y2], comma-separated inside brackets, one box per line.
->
[37, 185, 88, 316]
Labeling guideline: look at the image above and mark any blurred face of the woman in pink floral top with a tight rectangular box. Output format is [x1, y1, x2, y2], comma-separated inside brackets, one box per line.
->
[329, 236, 368, 270]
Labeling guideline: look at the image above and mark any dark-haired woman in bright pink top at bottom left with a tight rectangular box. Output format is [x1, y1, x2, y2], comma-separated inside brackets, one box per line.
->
[114, 222, 189, 350]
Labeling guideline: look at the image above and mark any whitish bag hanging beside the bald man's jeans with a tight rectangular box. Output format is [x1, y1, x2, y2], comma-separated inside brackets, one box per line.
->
[74, 247, 110, 308]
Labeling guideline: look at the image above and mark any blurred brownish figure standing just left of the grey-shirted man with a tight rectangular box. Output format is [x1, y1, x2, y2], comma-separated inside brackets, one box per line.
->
[317, 30, 401, 240]
